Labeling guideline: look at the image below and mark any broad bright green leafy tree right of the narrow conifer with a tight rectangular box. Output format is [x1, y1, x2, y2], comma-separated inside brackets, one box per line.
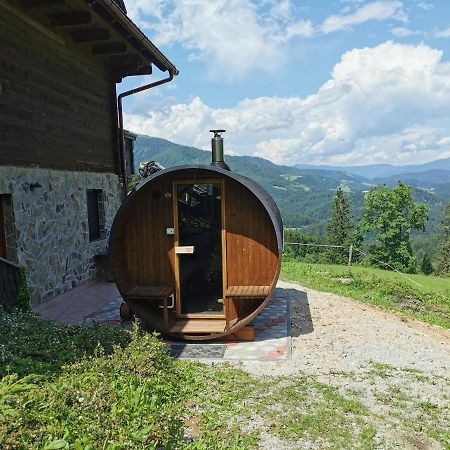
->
[359, 182, 428, 272]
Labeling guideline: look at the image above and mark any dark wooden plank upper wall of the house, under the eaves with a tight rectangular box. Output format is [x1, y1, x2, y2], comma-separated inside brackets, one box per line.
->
[0, 6, 117, 173]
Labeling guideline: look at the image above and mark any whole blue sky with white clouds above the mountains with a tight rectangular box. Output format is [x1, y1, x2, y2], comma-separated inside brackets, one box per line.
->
[118, 0, 450, 165]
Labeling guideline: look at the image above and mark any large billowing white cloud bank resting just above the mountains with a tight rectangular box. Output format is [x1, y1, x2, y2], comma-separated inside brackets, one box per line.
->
[125, 41, 450, 164]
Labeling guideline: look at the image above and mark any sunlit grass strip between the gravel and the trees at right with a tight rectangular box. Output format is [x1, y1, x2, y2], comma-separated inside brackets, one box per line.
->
[281, 258, 450, 328]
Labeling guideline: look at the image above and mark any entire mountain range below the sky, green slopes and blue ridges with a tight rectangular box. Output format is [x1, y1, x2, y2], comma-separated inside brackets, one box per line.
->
[134, 135, 450, 232]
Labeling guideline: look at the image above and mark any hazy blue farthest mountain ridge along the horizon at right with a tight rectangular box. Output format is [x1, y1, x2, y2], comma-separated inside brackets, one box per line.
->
[295, 158, 450, 180]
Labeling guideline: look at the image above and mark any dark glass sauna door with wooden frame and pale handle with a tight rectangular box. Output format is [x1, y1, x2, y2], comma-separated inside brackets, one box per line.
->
[174, 181, 224, 317]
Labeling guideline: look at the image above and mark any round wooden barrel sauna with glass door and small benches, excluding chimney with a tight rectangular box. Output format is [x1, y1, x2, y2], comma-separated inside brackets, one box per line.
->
[110, 166, 283, 340]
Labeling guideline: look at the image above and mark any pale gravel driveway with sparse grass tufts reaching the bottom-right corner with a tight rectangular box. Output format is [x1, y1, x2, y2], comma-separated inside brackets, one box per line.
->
[242, 281, 450, 449]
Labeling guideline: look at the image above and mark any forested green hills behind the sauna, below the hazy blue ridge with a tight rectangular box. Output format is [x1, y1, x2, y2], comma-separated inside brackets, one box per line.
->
[135, 135, 450, 232]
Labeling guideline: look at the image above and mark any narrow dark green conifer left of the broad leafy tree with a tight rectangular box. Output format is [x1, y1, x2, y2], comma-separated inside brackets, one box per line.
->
[326, 187, 354, 264]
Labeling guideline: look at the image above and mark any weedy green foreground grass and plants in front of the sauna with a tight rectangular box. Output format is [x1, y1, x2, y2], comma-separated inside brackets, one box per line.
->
[0, 313, 448, 450]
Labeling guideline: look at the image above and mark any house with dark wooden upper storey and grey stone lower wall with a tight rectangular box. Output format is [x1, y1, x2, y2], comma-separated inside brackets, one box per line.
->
[0, 0, 178, 304]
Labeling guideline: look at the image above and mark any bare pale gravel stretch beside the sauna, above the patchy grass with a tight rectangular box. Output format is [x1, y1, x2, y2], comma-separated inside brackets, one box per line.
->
[244, 281, 450, 377]
